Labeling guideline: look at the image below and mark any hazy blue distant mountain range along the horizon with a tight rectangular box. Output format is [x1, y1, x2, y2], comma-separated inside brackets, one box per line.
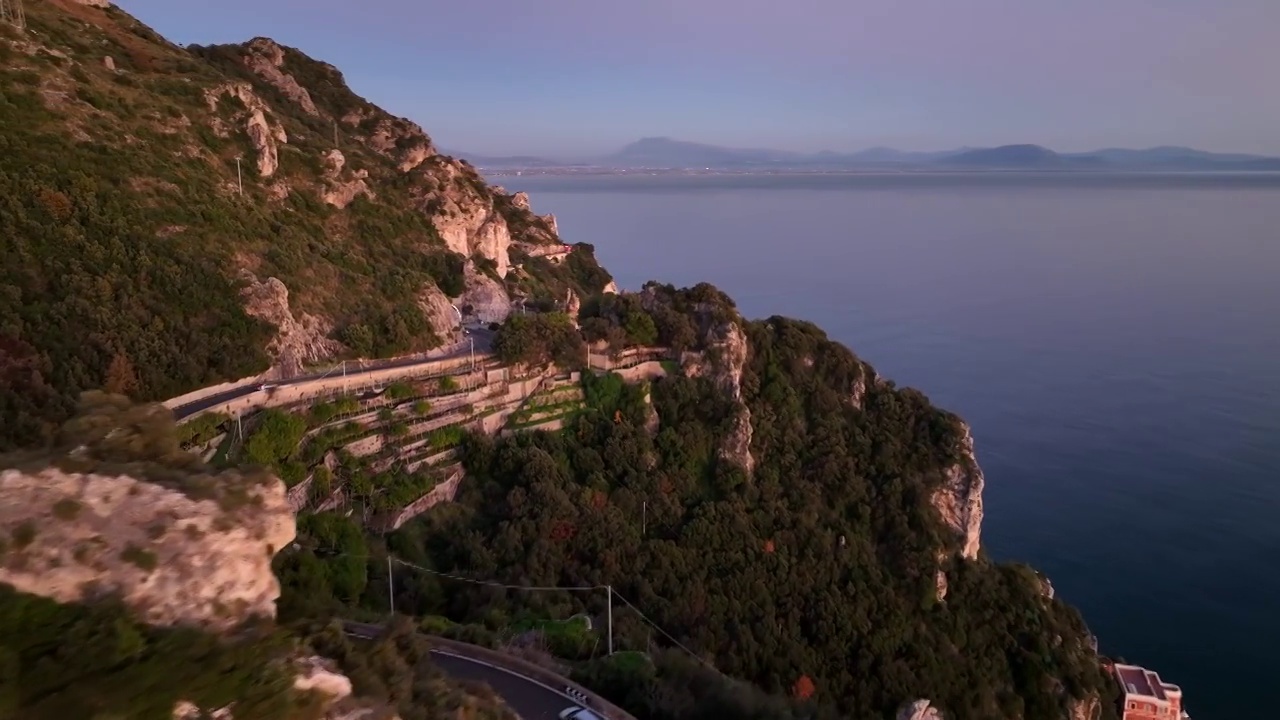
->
[445, 137, 1280, 172]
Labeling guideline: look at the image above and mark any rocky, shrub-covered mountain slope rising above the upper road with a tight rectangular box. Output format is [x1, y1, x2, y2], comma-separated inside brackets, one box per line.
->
[0, 0, 608, 450]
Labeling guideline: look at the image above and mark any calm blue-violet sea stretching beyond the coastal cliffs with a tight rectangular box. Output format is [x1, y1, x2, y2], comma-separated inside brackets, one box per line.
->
[499, 173, 1280, 720]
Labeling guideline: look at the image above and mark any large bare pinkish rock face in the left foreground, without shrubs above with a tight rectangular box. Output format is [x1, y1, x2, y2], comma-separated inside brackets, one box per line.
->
[0, 469, 294, 630]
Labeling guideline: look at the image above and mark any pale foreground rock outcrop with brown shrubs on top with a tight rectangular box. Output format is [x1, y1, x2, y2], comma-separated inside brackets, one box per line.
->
[0, 393, 294, 630]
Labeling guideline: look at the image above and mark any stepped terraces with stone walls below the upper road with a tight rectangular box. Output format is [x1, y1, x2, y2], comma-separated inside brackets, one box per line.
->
[180, 333, 680, 532]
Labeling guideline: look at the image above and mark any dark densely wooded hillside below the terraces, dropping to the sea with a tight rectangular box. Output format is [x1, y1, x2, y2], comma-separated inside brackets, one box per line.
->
[278, 286, 1114, 719]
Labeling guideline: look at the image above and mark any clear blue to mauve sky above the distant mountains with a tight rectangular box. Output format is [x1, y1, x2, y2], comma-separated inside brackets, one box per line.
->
[118, 0, 1280, 158]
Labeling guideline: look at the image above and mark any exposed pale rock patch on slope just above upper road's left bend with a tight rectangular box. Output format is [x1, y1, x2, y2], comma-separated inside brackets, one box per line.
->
[243, 272, 342, 377]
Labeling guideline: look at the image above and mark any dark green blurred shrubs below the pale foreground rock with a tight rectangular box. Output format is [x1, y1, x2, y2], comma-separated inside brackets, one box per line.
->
[0, 584, 304, 720]
